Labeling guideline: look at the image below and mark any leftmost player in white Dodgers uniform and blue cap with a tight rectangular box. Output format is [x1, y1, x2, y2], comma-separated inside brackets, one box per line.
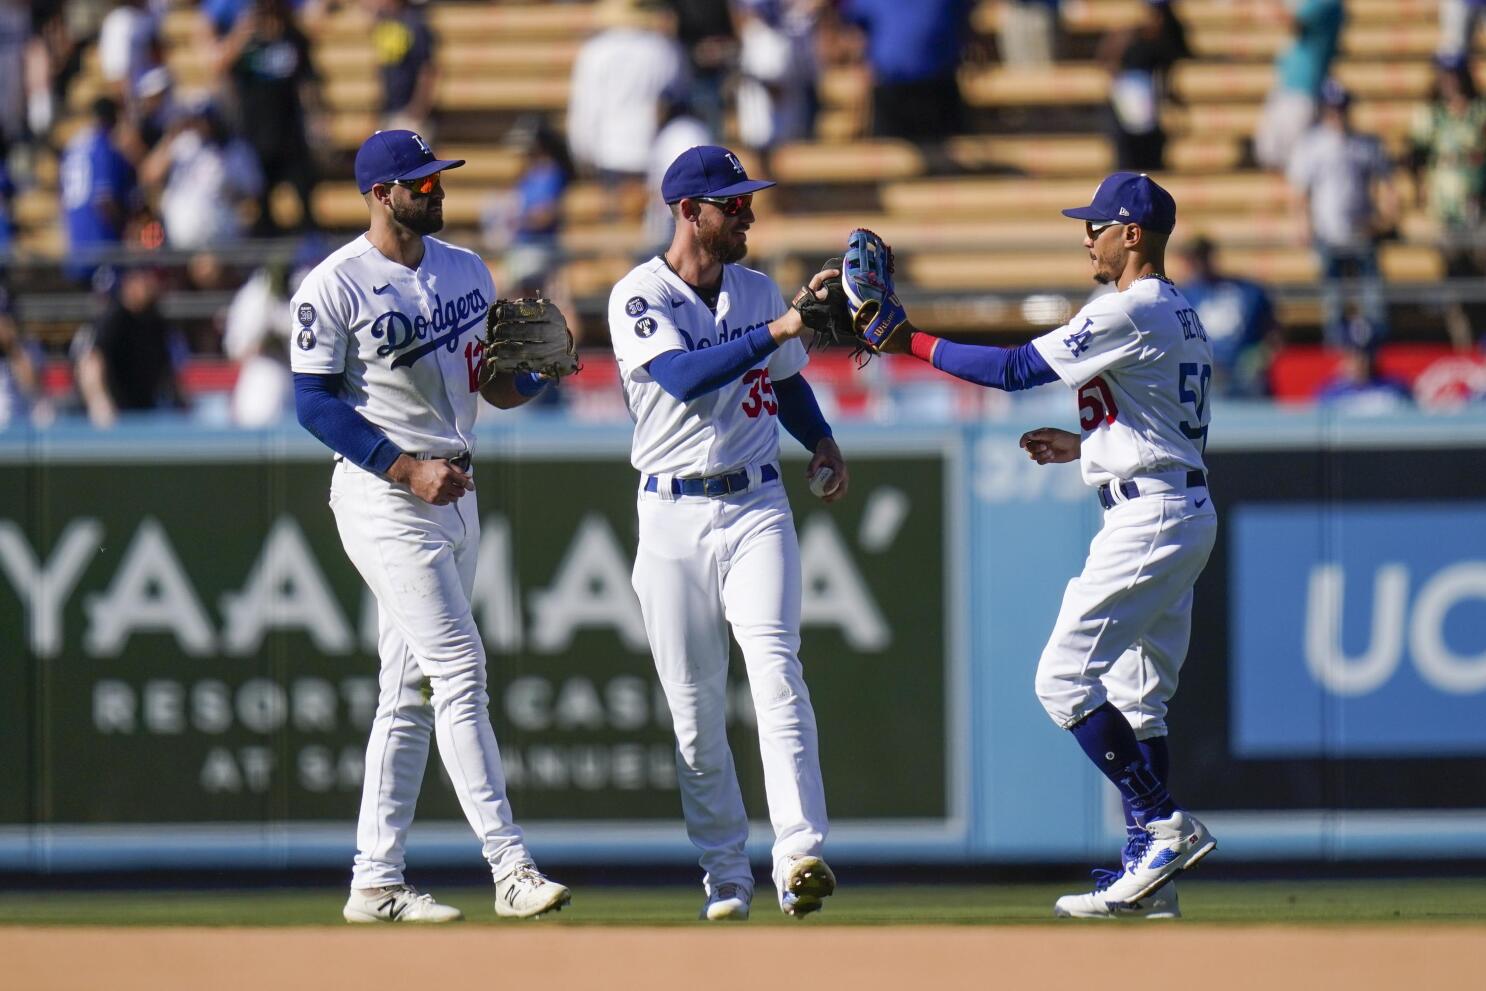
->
[290, 131, 569, 923]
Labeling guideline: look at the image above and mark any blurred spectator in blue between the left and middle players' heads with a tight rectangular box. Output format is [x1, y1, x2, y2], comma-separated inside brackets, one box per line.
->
[502, 117, 572, 296]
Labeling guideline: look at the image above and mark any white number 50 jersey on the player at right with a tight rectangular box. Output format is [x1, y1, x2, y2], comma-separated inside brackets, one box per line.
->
[1033, 278, 1213, 486]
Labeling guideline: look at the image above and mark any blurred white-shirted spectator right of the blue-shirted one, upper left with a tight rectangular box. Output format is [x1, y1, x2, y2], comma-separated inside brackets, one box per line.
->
[140, 100, 263, 250]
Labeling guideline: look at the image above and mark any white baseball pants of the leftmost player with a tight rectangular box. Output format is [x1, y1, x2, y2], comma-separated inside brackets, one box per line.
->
[330, 461, 531, 888]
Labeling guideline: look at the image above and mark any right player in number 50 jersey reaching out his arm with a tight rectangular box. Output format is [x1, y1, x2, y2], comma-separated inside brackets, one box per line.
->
[873, 172, 1217, 918]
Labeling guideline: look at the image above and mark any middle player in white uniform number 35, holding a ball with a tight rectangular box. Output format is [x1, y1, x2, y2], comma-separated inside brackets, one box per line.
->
[609, 146, 849, 920]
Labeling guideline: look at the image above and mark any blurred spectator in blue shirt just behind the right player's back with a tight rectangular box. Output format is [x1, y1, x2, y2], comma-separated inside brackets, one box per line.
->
[1180, 238, 1282, 398]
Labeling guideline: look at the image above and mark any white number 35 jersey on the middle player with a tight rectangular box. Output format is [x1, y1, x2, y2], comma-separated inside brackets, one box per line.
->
[609, 257, 808, 477]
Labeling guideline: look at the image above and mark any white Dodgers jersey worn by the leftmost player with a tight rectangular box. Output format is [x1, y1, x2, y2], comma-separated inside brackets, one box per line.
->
[290, 235, 495, 455]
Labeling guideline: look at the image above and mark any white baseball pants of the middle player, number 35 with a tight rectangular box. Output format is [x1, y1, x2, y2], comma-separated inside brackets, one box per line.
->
[633, 468, 829, 894]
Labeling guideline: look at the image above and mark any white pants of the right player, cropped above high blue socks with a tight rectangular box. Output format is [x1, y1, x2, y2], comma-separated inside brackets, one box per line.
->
[1037, 486, 1217, 740]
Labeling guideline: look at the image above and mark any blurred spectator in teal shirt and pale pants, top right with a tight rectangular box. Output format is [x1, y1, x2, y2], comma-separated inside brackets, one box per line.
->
[1254, 0, 1346, 171]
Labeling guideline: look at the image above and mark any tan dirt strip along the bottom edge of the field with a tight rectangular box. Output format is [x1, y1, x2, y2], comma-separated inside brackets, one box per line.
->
[0, 924, 1486, 991]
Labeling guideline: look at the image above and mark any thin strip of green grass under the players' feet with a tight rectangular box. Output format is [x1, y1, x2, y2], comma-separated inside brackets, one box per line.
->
[0, 880, 1486, 926]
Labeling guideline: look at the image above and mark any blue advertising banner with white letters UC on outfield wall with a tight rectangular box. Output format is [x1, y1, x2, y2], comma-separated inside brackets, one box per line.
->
[1229, 502, 1486, 758]
